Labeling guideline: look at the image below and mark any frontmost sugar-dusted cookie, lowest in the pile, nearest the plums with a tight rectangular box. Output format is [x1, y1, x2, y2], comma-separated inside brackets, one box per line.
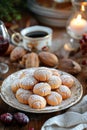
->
[28, 94, 46, 109]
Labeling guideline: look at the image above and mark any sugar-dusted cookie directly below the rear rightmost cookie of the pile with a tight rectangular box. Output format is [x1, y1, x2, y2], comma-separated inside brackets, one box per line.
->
[56, 85, 71, 100]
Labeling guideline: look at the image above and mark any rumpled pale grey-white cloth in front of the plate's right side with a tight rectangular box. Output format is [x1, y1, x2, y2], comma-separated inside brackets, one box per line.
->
[41, 95, 87, 130]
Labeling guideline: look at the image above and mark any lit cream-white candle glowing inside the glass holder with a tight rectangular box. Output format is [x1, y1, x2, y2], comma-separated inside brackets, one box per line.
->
[70, 14, 87, 35]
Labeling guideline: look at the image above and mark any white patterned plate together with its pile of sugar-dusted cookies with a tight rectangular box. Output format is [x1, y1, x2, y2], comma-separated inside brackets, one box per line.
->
[1, 67, 83, 113]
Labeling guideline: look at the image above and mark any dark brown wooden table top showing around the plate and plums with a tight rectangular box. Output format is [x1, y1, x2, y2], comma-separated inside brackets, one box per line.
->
[0, 24, 87, 130]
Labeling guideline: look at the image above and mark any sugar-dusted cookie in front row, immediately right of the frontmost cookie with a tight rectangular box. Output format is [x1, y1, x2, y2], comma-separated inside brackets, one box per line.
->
[46, 91, 62, 106]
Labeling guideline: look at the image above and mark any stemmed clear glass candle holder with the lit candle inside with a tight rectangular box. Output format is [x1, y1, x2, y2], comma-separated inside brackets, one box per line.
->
[64, 0, 87, 50]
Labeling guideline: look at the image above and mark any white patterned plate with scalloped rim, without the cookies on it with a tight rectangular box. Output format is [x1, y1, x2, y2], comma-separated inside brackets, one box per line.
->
[1, 68, 83, 113]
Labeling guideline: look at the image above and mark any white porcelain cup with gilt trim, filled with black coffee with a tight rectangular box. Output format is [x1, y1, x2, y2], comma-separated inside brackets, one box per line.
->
[11, 26, 53, 51]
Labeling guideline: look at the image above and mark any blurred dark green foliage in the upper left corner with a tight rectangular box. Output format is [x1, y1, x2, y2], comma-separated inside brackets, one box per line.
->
[0, 0, 27, 21]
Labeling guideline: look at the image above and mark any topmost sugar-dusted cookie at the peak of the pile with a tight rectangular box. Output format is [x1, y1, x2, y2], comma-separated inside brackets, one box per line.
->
[34, 67, 52, 81]
